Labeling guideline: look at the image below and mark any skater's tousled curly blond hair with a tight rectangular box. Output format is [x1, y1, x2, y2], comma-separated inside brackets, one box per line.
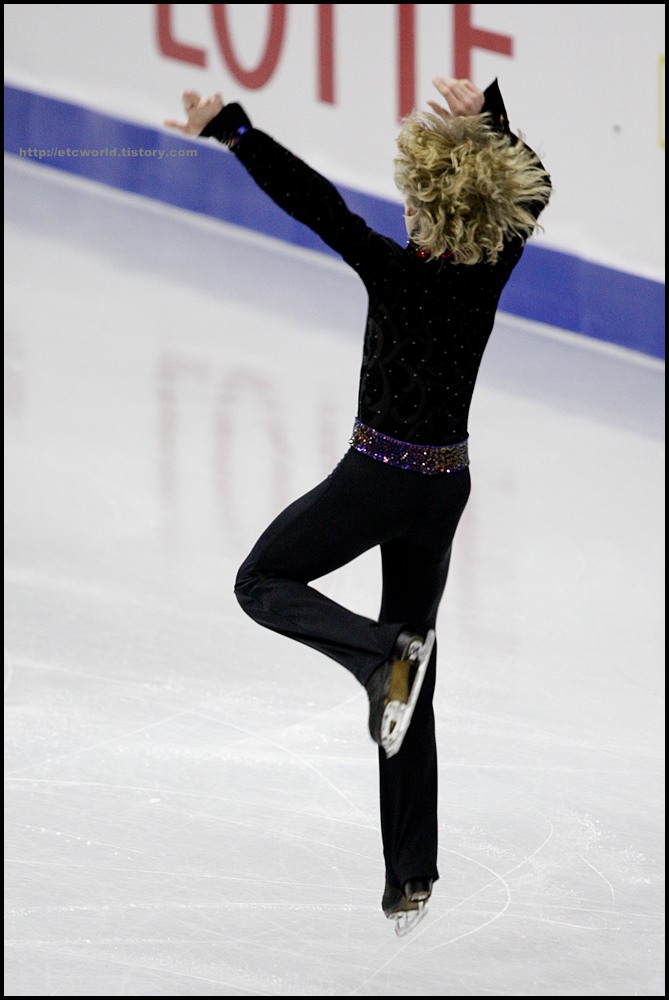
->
[394, 111, 551, 264]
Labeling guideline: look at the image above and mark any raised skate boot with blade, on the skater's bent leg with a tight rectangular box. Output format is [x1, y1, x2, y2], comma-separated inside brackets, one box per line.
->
[365, 629, 435, 757]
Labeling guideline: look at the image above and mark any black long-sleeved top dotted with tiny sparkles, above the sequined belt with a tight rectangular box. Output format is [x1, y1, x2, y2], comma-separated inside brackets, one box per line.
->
[202, 81, 548, 445]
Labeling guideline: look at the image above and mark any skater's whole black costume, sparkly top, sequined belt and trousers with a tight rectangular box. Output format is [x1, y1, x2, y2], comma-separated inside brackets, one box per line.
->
[202, 82, 548, 900]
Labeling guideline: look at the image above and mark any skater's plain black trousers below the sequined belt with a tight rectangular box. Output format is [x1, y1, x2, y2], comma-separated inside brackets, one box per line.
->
[235, 449, 470, 887]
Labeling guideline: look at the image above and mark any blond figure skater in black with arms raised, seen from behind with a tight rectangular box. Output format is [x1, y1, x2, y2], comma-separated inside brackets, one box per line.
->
[165, 77, 551, 933]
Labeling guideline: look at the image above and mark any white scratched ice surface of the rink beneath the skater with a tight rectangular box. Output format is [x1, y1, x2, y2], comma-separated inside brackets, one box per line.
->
[5, 159, 665, 997]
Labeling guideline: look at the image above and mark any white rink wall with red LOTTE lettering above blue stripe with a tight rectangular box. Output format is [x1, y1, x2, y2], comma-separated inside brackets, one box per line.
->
[4, 4, 665, 280]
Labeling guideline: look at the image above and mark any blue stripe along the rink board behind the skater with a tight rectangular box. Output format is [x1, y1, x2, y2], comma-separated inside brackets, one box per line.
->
[5, 84, 665, 359]
